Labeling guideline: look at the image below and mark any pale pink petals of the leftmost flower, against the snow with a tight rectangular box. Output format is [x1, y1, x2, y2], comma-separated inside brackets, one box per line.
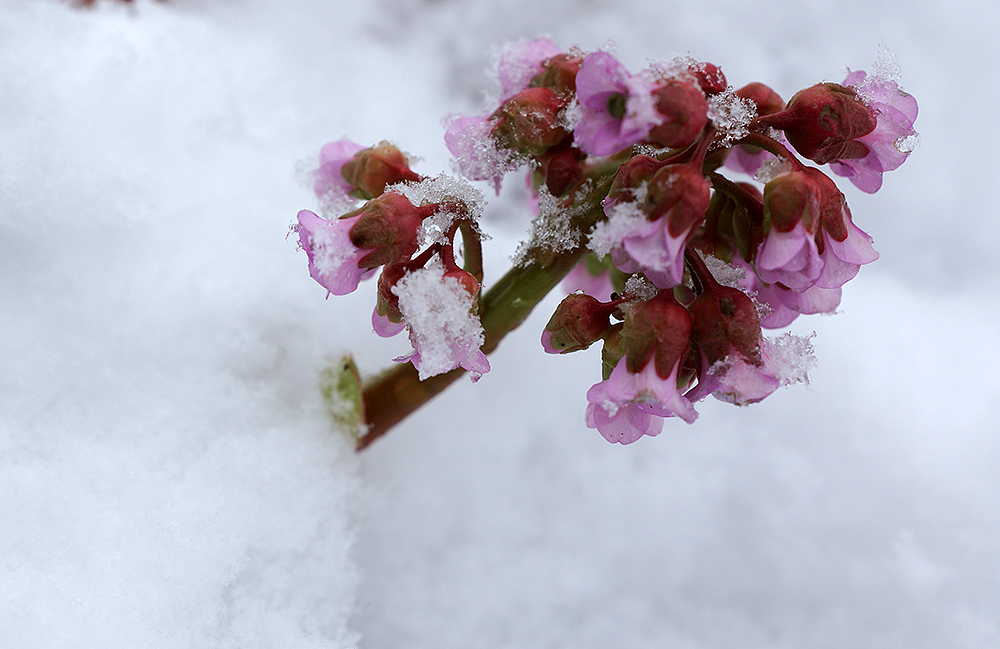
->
[295, 210, 375, 295]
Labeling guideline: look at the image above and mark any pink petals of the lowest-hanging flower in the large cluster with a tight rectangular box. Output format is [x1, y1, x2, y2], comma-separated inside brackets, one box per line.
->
[587, 357, 698, 444]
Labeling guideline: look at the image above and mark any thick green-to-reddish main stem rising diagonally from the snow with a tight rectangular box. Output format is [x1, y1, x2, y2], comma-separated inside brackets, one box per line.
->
[357, 173, 614, 451]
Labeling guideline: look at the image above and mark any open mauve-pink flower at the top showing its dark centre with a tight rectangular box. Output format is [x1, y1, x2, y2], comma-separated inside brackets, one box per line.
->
[574, 52, 664, 156]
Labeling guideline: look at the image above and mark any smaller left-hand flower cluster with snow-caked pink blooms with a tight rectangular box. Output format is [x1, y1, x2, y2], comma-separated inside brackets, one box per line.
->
[293, 140, 490, 380]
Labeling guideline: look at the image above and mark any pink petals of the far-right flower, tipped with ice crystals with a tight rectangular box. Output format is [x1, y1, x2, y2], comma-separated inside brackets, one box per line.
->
[831, 70, 917, 194]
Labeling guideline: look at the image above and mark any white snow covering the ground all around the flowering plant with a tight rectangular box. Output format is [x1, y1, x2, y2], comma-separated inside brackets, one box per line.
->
[0, 0, 1000, 649]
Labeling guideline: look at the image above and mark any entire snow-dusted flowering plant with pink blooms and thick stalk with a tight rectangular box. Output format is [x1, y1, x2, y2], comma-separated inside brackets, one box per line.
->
[293, 39, 917, 449]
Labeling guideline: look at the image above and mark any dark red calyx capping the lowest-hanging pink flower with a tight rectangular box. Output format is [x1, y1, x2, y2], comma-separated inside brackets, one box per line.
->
[622, 291, 691, 378]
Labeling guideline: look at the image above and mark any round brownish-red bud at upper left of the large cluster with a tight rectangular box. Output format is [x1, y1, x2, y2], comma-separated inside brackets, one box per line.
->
[491, 88, 566, 157]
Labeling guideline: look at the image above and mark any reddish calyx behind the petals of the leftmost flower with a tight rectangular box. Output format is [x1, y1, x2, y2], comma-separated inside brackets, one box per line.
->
[342, 192, 424, 268]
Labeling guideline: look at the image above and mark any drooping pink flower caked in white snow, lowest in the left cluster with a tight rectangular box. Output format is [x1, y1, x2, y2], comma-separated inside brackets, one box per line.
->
[392, 258, 490, 381]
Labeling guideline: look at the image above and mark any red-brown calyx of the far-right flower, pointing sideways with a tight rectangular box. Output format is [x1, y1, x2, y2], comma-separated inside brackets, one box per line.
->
[761, 83, 876, 164]
